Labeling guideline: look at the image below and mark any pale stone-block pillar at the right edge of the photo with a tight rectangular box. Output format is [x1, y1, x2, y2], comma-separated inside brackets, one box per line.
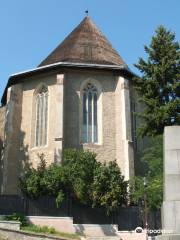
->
[162, 126, 180, 233]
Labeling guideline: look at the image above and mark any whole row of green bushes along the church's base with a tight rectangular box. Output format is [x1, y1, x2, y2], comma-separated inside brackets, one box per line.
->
[20, 149, 127, 214]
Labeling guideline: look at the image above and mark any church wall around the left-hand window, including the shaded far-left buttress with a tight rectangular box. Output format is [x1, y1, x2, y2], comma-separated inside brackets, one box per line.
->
[0, 73, 61, 194]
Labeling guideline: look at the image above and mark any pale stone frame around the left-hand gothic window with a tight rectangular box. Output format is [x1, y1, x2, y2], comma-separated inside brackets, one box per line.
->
[31, 83, 50, 149]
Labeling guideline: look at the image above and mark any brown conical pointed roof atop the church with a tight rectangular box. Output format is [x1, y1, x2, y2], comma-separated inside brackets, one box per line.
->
[39, 17, 126, 67]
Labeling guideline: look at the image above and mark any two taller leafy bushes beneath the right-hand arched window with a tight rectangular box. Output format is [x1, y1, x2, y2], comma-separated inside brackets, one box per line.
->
[63, 150, 127, 214]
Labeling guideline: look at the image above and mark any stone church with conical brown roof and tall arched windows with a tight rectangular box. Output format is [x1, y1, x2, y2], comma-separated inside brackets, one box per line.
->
[0, 16, 135, 194]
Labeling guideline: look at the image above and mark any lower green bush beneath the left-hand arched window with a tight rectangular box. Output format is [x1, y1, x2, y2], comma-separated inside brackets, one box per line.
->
[20, 154, 66, 205]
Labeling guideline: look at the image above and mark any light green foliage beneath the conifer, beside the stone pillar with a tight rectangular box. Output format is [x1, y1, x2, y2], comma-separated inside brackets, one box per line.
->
[130, 135, 163, 211]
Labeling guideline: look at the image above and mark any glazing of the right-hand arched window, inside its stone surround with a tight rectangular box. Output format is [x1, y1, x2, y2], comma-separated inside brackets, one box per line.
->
[82, 83, 98, 143]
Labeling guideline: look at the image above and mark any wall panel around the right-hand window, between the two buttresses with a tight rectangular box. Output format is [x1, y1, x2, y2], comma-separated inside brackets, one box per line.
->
[64, 72, 116, 162]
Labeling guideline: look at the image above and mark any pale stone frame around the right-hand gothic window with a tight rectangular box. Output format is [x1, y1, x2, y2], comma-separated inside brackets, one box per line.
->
[79, 78, 103, 145]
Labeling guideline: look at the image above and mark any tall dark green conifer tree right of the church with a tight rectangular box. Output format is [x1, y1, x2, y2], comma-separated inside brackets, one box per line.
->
[134, 26, 180, 136]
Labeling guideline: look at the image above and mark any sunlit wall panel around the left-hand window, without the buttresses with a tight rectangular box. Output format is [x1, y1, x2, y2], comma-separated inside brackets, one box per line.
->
[20, 74, 57, 168]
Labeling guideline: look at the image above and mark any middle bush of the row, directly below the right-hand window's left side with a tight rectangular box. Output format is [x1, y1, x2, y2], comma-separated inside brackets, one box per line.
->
[63, 149, 99, 204]
